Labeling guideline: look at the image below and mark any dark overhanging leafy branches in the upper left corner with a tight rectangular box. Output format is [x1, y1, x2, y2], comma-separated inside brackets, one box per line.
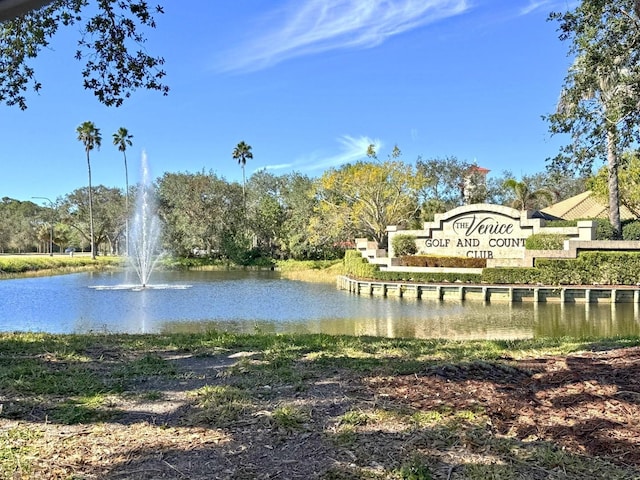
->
[0, 0, 169, 110]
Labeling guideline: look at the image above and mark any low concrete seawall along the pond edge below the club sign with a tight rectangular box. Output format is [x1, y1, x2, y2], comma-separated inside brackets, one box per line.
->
[337, 276, 640, 304]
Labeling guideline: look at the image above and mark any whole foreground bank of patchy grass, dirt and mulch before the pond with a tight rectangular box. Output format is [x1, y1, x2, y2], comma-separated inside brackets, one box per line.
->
[0, 331, 640, 480]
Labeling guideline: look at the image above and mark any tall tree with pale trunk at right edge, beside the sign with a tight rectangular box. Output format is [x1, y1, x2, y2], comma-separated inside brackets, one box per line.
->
[547, 0, 640, 238]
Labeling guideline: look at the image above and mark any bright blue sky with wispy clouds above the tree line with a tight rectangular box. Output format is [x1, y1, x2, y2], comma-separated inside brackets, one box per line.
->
[0, 0, 575, 202]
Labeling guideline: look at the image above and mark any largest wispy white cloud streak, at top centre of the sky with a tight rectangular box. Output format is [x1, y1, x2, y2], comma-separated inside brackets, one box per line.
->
[218, 0, 470, 72]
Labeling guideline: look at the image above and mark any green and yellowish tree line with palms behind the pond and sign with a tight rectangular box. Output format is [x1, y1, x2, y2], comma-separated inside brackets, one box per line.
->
[0, 139, 597, 264]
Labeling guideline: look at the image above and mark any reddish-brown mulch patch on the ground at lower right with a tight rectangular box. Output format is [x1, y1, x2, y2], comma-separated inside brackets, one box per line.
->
[370, 348, 640, 466]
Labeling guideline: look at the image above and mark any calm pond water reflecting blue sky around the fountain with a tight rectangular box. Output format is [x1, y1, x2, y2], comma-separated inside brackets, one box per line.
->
[0, 272, 640, 339]
